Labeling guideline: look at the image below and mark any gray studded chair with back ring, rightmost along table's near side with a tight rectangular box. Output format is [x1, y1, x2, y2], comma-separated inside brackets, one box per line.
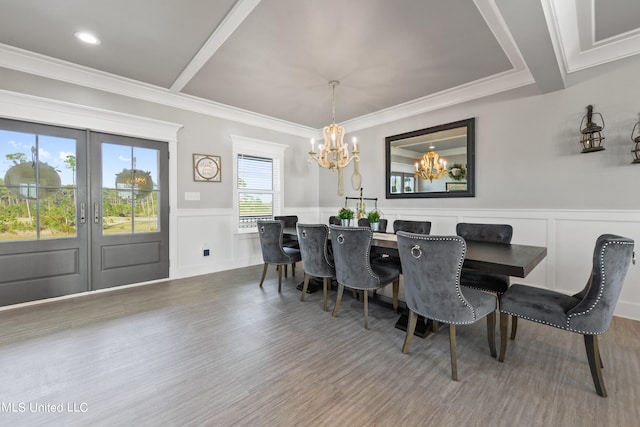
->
[397, 231, 497, 381]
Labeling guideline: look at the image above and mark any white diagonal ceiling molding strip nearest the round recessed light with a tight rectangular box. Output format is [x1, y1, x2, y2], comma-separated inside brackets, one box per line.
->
[170, 0, 261, 92]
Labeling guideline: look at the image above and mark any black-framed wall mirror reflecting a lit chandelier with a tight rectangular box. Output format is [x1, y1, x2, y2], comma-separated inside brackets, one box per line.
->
[385, 118, 475, 199]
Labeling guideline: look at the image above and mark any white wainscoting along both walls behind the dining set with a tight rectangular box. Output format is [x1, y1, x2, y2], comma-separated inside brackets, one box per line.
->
[172, 207, 640, 320]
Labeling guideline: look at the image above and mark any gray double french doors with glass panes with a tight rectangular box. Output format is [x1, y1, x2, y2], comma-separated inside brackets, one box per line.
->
[0, 119, 169, 305]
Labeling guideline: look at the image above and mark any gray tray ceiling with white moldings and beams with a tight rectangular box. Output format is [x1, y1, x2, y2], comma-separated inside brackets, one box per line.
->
[0, 0, 640, 129]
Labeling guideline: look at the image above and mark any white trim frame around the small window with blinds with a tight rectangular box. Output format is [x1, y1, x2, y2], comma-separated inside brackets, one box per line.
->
[231, 135, 287, 234]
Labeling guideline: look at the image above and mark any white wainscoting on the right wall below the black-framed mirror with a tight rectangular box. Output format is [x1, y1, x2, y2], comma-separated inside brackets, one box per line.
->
[320, 207, 640, 320]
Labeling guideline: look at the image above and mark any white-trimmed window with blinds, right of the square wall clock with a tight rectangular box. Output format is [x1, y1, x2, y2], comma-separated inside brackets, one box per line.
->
[231, 135, 286, 232]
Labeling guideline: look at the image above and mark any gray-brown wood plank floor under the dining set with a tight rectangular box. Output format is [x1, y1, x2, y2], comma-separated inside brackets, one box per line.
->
[0, 266, 640, 427]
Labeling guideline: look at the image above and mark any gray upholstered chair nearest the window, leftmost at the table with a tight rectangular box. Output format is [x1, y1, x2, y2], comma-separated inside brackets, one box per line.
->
[258, 220, 302, 292]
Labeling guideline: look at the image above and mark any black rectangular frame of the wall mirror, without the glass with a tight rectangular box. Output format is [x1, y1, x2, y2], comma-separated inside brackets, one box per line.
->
[384, 117, 476, 199]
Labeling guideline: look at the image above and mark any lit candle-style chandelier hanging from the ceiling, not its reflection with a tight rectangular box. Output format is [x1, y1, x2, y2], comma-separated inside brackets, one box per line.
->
[308, 80, 362, 196]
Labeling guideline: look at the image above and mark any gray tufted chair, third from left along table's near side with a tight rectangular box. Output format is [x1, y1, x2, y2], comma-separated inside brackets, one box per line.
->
[330, 225, 400, 329]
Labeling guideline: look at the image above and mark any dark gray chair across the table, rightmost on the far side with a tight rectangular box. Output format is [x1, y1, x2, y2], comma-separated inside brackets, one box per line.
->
[456, 222, 518, 339]
